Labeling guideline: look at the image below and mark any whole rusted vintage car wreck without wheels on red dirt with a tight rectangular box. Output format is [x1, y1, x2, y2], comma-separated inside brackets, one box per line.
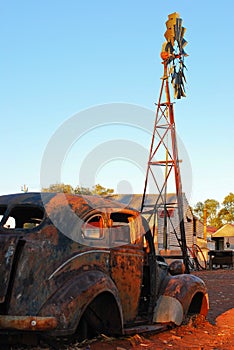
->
[0, 193, 208, 339]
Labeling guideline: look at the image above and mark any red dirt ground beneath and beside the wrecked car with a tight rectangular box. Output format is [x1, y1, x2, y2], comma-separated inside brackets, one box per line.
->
[7, 269, 234, 350]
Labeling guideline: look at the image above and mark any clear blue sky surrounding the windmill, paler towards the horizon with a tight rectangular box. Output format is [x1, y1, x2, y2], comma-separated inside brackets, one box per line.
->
[0, 0, 234, 205]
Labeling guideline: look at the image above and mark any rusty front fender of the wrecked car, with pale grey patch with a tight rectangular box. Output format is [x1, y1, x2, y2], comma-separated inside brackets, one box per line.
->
[153, 274, 209, 325]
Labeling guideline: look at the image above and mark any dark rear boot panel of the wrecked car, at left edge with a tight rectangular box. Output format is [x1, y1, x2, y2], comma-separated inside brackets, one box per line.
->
[0, 235, 19, 303]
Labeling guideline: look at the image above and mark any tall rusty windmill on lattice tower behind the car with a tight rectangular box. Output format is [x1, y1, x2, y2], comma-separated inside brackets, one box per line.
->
[141, 12, 189, 272]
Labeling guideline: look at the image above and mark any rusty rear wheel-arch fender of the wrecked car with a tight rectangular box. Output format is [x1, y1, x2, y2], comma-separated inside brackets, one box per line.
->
[39, 270, 123, 335]
